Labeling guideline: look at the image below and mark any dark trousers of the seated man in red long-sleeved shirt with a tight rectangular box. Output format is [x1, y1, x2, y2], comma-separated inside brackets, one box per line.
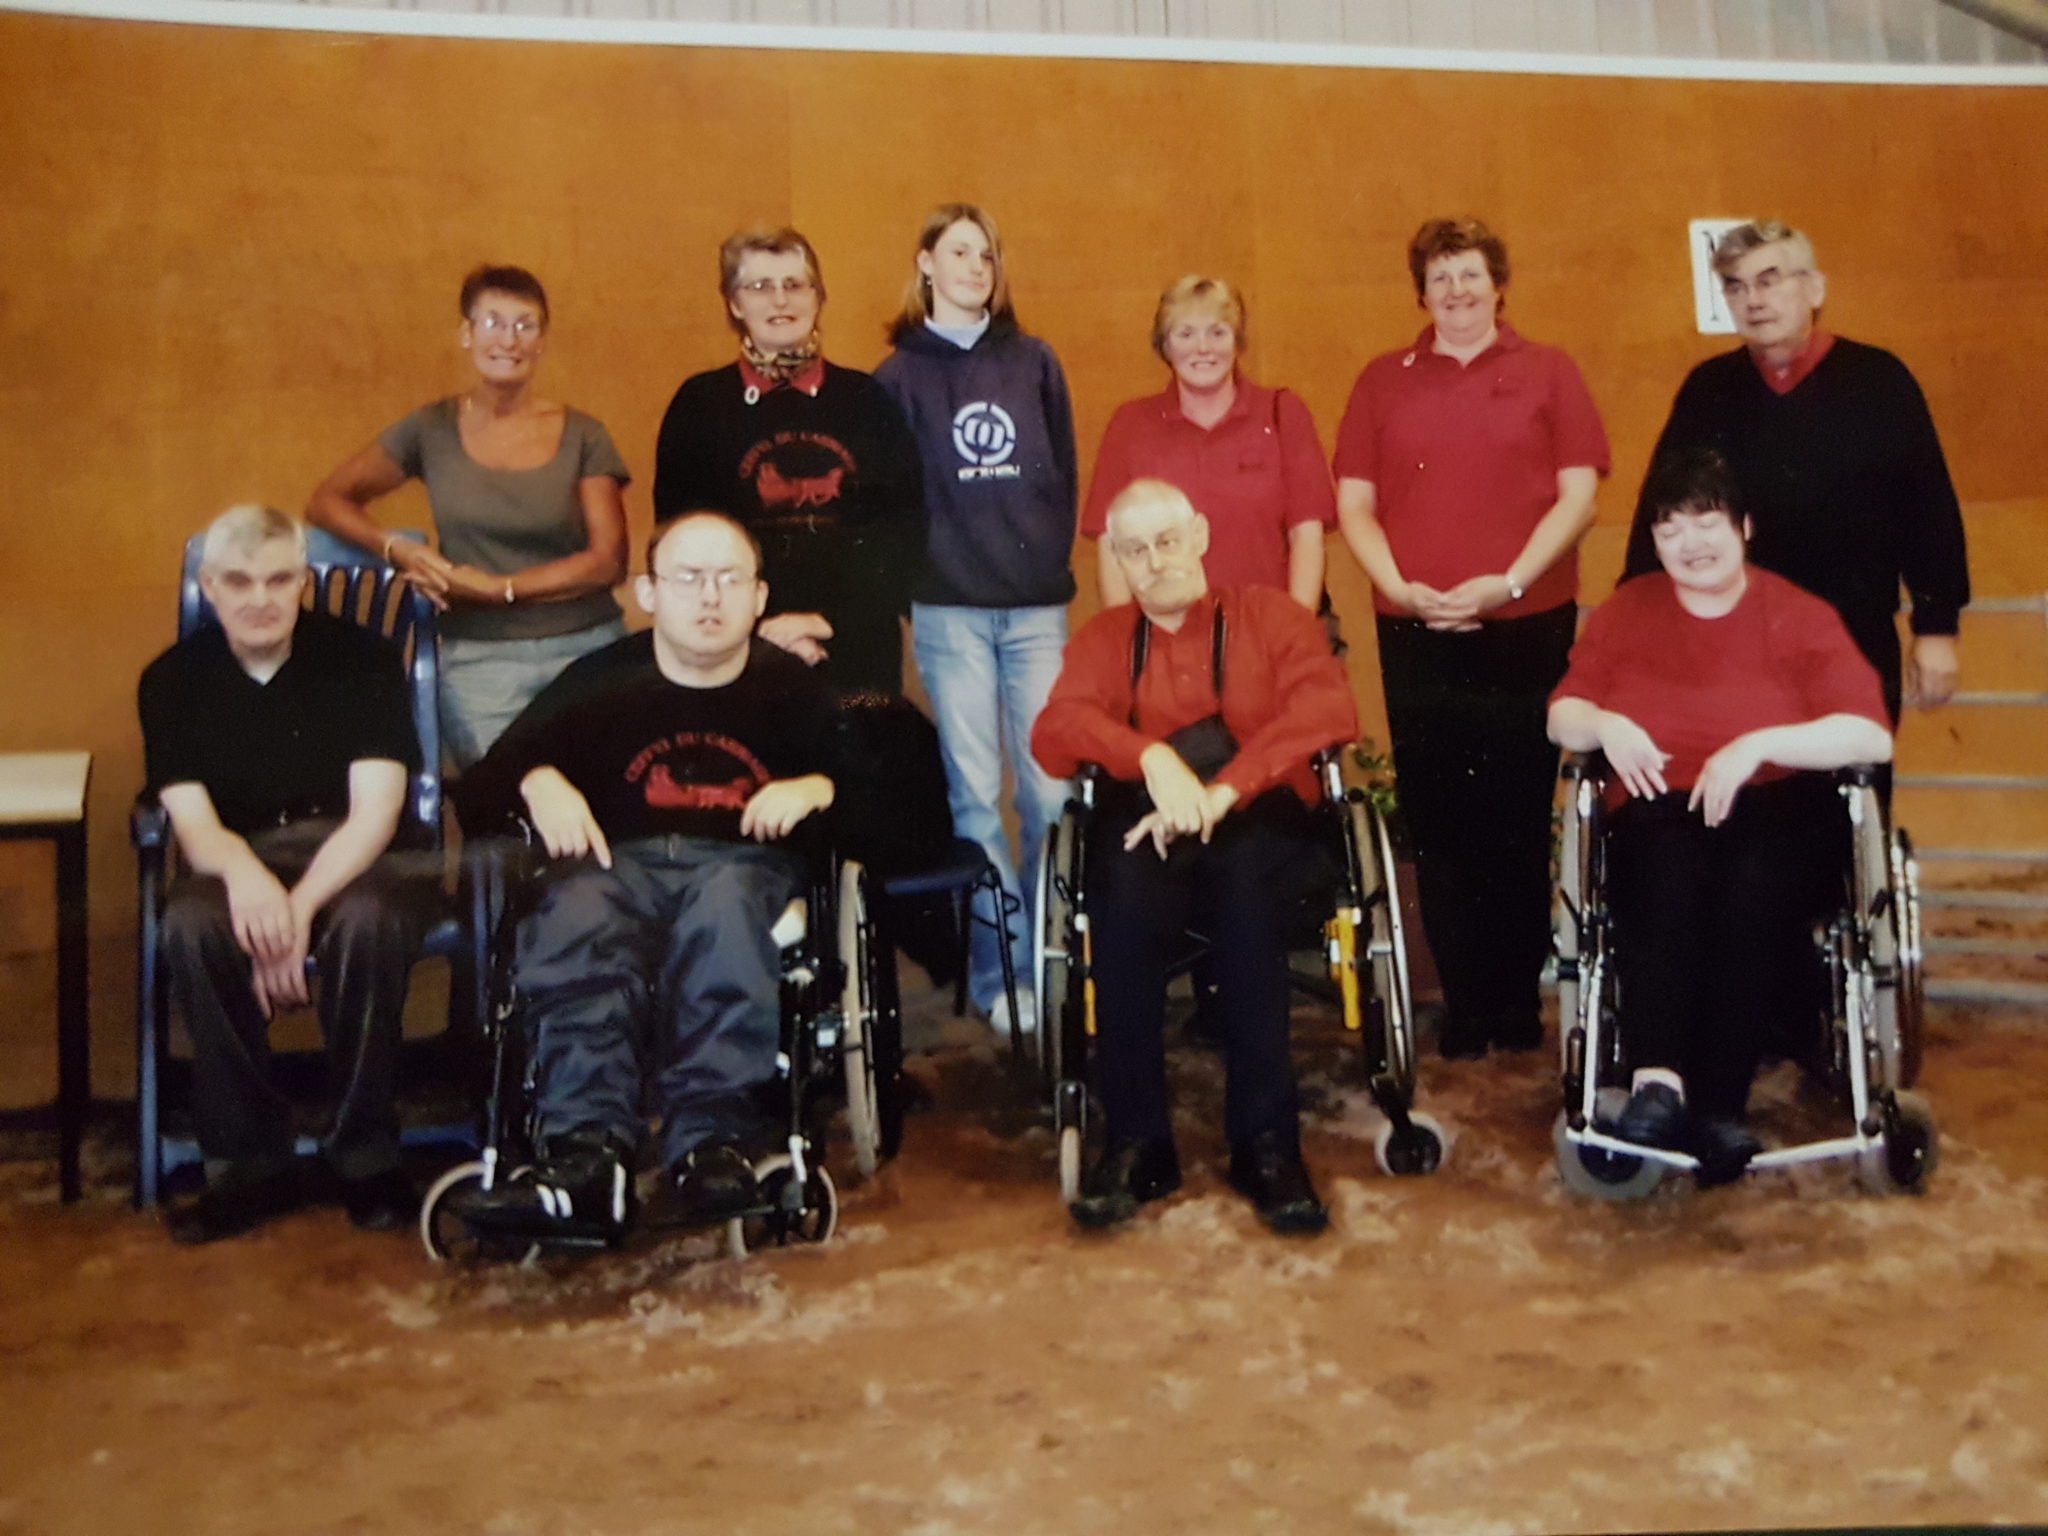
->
[1087, 788, 1319, 1143]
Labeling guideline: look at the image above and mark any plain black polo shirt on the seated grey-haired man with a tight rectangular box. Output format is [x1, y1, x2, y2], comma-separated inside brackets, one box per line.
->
[135, 612, 420, 834]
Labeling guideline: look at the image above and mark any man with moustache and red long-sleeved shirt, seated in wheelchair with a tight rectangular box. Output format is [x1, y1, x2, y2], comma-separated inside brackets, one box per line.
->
[1032, 479, 1358, 1233]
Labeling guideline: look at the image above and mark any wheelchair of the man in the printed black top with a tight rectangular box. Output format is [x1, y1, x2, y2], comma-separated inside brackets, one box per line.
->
[420, 860, 903, 1264]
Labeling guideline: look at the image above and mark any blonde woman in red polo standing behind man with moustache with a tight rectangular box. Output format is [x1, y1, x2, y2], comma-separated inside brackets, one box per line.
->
[1081, 276, 1337, 612]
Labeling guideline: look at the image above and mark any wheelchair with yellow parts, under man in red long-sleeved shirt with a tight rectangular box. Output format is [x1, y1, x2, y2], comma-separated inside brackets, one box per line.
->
[1030, 748, 1448, 1204]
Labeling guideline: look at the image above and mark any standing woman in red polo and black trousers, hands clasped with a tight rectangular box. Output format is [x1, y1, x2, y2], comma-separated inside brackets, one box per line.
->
[1335, 219, 1608, 1057]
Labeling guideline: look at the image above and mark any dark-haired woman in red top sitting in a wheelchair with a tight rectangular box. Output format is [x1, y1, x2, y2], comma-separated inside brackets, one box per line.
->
[1550, 451, 1892, 1186]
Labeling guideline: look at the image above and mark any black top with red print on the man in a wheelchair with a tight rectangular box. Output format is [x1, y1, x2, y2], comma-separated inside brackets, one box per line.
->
[461, 631, 838, 856]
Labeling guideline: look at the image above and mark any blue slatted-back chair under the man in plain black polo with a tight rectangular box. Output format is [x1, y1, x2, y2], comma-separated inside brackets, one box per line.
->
[129, 528, 500, 1206]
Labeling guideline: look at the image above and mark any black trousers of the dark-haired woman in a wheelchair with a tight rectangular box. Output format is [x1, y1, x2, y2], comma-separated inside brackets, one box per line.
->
[1606, 774, 1849, 1116]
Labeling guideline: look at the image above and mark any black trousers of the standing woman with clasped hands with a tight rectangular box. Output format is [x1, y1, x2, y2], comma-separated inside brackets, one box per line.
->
[1378, 604, 1577, 1042]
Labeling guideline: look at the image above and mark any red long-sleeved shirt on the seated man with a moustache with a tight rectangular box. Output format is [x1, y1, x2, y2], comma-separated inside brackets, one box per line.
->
[1030, 586, 1358, 805]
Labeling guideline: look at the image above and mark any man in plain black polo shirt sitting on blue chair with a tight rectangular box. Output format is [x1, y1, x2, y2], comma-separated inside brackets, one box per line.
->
[137, 506, 438, 1243]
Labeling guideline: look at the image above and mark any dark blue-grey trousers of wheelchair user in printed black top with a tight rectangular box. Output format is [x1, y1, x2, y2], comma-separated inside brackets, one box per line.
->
[516, 838, 803, 1165]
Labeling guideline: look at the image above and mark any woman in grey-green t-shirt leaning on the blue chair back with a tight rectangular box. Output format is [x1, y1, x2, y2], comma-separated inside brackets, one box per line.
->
[305, 266, 631, 770]
